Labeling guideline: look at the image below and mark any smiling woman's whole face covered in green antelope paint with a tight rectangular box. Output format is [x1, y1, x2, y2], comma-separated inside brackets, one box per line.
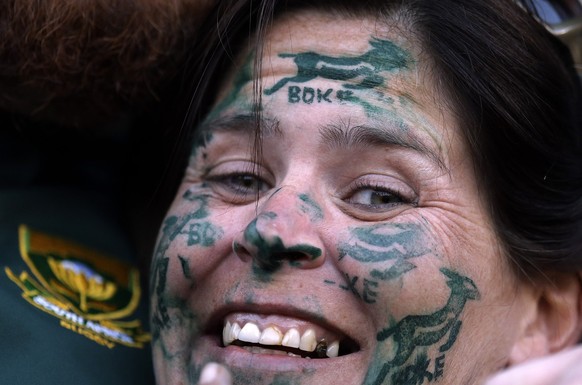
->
[151, 12, 527, 385]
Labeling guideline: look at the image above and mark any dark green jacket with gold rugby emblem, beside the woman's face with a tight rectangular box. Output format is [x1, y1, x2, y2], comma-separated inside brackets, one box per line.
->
[0, 117, 154, 385]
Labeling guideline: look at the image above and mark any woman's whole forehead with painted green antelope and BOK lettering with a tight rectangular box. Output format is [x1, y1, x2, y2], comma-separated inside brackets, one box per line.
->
[208, 10, 458, 163]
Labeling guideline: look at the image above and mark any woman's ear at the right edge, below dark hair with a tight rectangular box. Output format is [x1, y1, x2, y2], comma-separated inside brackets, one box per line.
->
[509, 273, 582, 366]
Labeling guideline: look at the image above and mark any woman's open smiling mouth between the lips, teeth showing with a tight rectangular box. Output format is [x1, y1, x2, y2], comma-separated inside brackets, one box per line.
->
[222, 314, 359, 359]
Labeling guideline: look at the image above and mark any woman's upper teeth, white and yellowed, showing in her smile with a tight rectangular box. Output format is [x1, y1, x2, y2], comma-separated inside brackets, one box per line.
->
[222, 321, 339, 358]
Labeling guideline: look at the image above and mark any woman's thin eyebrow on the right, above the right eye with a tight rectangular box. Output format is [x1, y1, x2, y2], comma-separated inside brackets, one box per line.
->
[319, 121, 449, 171]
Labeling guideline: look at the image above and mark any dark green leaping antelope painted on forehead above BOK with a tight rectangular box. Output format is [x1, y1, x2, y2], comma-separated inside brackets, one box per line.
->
[265, 38, 411, 95]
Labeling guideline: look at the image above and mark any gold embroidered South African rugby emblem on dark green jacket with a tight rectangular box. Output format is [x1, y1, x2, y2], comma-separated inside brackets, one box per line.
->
[5, 225, 150, 348]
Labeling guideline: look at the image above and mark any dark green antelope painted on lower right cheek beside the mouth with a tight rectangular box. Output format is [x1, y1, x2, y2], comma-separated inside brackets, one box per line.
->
[364, 268, 480, 385]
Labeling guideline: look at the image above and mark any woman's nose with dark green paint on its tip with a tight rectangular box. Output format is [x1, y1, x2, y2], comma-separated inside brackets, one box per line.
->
[233, 191, 325, 277]
